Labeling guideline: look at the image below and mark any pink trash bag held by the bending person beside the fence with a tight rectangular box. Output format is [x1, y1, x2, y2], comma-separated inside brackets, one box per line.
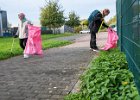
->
[101, 28, 118, 51]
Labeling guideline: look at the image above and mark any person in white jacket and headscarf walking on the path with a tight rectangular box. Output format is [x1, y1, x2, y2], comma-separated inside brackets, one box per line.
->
[15, 13, 30, 58]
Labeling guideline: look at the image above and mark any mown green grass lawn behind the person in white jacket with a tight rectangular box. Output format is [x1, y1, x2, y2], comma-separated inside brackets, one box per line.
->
[0, 33, 74, 60]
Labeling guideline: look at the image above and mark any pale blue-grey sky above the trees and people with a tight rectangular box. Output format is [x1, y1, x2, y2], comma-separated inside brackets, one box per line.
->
[0, 0, 116, 26]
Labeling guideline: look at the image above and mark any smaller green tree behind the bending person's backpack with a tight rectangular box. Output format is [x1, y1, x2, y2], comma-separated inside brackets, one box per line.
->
[65, 11, 80, 28]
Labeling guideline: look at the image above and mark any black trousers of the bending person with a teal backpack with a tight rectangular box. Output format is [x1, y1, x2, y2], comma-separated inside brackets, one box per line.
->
[90, 30, 97, 49]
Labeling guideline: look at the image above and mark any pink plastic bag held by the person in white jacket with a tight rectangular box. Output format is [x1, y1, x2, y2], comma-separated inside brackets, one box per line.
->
[24, 25, 43, 55]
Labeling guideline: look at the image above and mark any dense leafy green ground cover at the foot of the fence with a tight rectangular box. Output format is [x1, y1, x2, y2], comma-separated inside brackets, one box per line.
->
[64, 49, 140, 100]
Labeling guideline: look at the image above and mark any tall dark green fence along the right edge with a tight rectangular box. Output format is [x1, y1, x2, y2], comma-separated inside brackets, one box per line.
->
[116, 0, 140, 92]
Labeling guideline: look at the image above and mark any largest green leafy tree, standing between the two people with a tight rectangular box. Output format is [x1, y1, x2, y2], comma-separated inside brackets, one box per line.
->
[40, 0, 65, 30]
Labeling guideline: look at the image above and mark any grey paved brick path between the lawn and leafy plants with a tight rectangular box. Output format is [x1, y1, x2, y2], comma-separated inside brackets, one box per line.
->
[0, 34, 106, 100]
